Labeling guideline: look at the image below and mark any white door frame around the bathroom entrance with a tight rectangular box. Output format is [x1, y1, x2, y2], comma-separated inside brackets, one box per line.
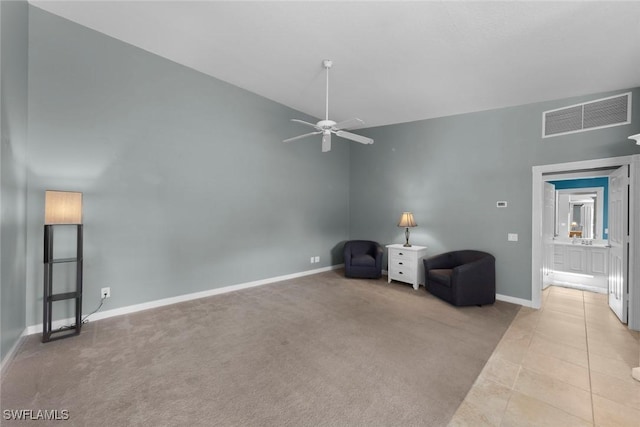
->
[531, 154, 640, 331]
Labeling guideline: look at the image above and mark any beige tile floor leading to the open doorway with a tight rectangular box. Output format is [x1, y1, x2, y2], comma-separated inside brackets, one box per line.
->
[449, 286, 640, 427]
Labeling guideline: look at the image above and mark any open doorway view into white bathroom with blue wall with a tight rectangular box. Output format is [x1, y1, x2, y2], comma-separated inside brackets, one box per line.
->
[542, 165, 629, 324]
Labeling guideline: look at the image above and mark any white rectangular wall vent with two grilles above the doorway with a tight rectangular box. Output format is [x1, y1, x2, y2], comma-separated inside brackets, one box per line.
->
[542, 92, 631, 138]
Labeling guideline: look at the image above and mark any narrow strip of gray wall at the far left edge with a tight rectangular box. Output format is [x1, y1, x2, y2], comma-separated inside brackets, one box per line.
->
[0, 1, 28, 360]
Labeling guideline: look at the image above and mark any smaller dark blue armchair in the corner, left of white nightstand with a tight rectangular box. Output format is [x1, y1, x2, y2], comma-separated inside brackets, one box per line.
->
[344, 240, 384, 279]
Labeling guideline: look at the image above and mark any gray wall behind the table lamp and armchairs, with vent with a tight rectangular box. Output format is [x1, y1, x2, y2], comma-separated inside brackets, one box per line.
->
[350, 89, 640, 300]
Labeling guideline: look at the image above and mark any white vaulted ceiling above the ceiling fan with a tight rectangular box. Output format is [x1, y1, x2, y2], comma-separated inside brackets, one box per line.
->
[30, 1, 640, 127]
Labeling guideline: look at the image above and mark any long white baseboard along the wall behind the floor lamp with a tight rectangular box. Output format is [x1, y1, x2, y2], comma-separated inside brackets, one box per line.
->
[23, 264, 344, 335]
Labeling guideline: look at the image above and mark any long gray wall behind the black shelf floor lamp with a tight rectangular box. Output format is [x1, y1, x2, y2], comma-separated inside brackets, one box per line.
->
[27, 7, 349, 325]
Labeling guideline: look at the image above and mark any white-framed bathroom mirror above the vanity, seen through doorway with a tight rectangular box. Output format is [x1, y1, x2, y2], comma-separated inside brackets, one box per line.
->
[556, 188, 605, 239]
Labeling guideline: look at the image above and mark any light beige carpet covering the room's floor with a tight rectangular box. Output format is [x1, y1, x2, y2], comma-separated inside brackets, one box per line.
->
[1, 271, 519, 426]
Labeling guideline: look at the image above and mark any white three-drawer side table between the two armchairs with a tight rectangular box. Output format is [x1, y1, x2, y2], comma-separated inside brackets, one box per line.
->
[387, 244, 427, 289]
